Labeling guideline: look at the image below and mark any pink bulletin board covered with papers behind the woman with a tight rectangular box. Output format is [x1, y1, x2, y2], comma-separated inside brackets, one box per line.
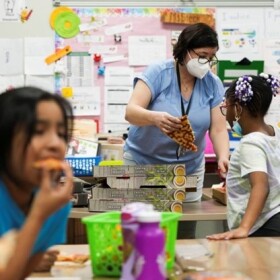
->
[55, 7, 215, 132]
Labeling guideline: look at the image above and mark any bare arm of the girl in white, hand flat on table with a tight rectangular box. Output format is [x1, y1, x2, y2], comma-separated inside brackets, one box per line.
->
[207, 172, 269, 240]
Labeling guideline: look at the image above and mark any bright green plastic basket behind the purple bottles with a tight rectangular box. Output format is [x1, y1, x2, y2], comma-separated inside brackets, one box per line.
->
[82, 211, 182, 276]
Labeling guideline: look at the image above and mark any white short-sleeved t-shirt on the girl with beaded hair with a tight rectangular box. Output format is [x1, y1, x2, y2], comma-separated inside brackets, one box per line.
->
[227, 127, 280, 234]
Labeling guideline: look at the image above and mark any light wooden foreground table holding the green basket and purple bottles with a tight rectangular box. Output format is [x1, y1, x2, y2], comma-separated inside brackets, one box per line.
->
[28, 237, 280, 280]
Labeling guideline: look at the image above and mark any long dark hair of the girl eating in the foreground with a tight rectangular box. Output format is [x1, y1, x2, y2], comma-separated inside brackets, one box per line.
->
[0, 87, 73, 172]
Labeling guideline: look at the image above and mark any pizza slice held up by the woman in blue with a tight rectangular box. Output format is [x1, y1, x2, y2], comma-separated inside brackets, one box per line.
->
[168, 115, 197, 152]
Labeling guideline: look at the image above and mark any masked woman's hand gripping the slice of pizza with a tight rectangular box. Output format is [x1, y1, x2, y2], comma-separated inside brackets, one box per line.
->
[154, 112, 182, 134]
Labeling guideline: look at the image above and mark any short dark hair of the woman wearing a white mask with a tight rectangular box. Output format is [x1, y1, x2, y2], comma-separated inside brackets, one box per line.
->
[173, 23, 219, 64]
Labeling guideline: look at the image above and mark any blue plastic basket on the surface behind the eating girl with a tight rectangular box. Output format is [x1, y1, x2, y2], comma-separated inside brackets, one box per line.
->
[65, 156, 102, 176]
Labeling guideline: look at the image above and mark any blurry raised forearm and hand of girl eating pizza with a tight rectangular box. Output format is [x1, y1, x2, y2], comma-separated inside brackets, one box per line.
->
[0, 163, 73, 280]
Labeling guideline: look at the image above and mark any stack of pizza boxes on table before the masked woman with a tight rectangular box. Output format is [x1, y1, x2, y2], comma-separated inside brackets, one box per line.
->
[89, 164, 197, 212]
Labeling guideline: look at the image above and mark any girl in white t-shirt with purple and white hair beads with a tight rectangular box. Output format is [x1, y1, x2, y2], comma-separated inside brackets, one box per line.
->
[207, 74, 280, 240]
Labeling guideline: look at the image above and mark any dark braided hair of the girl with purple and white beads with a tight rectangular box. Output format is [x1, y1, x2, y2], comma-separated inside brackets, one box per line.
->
[225, 75, 273, 117]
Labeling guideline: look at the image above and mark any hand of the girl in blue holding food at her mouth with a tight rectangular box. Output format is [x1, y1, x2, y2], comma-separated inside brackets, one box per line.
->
[30, 162, 73, 221]
